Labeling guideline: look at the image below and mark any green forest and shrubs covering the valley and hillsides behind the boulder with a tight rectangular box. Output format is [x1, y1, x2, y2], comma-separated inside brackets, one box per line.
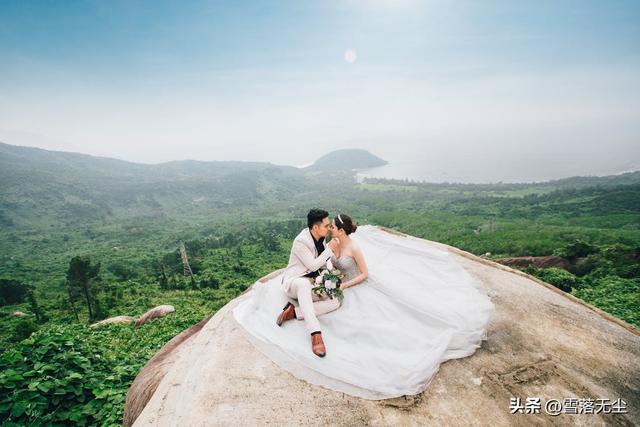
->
[0, 144, 640, 425]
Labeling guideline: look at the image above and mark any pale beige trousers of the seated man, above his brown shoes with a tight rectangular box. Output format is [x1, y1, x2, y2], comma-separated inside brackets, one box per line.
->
[284, 277, 340, 333]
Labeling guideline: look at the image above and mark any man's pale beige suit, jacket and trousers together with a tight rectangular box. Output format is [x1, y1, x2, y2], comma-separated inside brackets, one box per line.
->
[281, 227, 340, 333]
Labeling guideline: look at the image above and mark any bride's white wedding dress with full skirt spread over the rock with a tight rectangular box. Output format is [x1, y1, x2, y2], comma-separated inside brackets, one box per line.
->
[233, 225, 495, 400]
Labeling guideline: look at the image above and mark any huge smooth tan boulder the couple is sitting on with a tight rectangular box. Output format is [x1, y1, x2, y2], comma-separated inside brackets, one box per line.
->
[124, 230, 640, 426]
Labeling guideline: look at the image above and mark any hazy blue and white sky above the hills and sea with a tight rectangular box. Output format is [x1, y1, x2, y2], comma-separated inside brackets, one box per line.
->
[0, 0, 640, 181]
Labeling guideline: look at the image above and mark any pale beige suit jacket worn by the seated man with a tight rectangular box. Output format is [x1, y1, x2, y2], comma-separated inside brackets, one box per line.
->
[281, 227, 333, 289]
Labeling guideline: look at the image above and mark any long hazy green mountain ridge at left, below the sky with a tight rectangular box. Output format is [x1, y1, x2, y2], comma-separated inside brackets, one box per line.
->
[0, 143, 307, 228]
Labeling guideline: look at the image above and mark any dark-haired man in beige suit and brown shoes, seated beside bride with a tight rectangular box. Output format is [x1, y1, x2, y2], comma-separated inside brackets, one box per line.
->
[276, 209, 340, 357]
